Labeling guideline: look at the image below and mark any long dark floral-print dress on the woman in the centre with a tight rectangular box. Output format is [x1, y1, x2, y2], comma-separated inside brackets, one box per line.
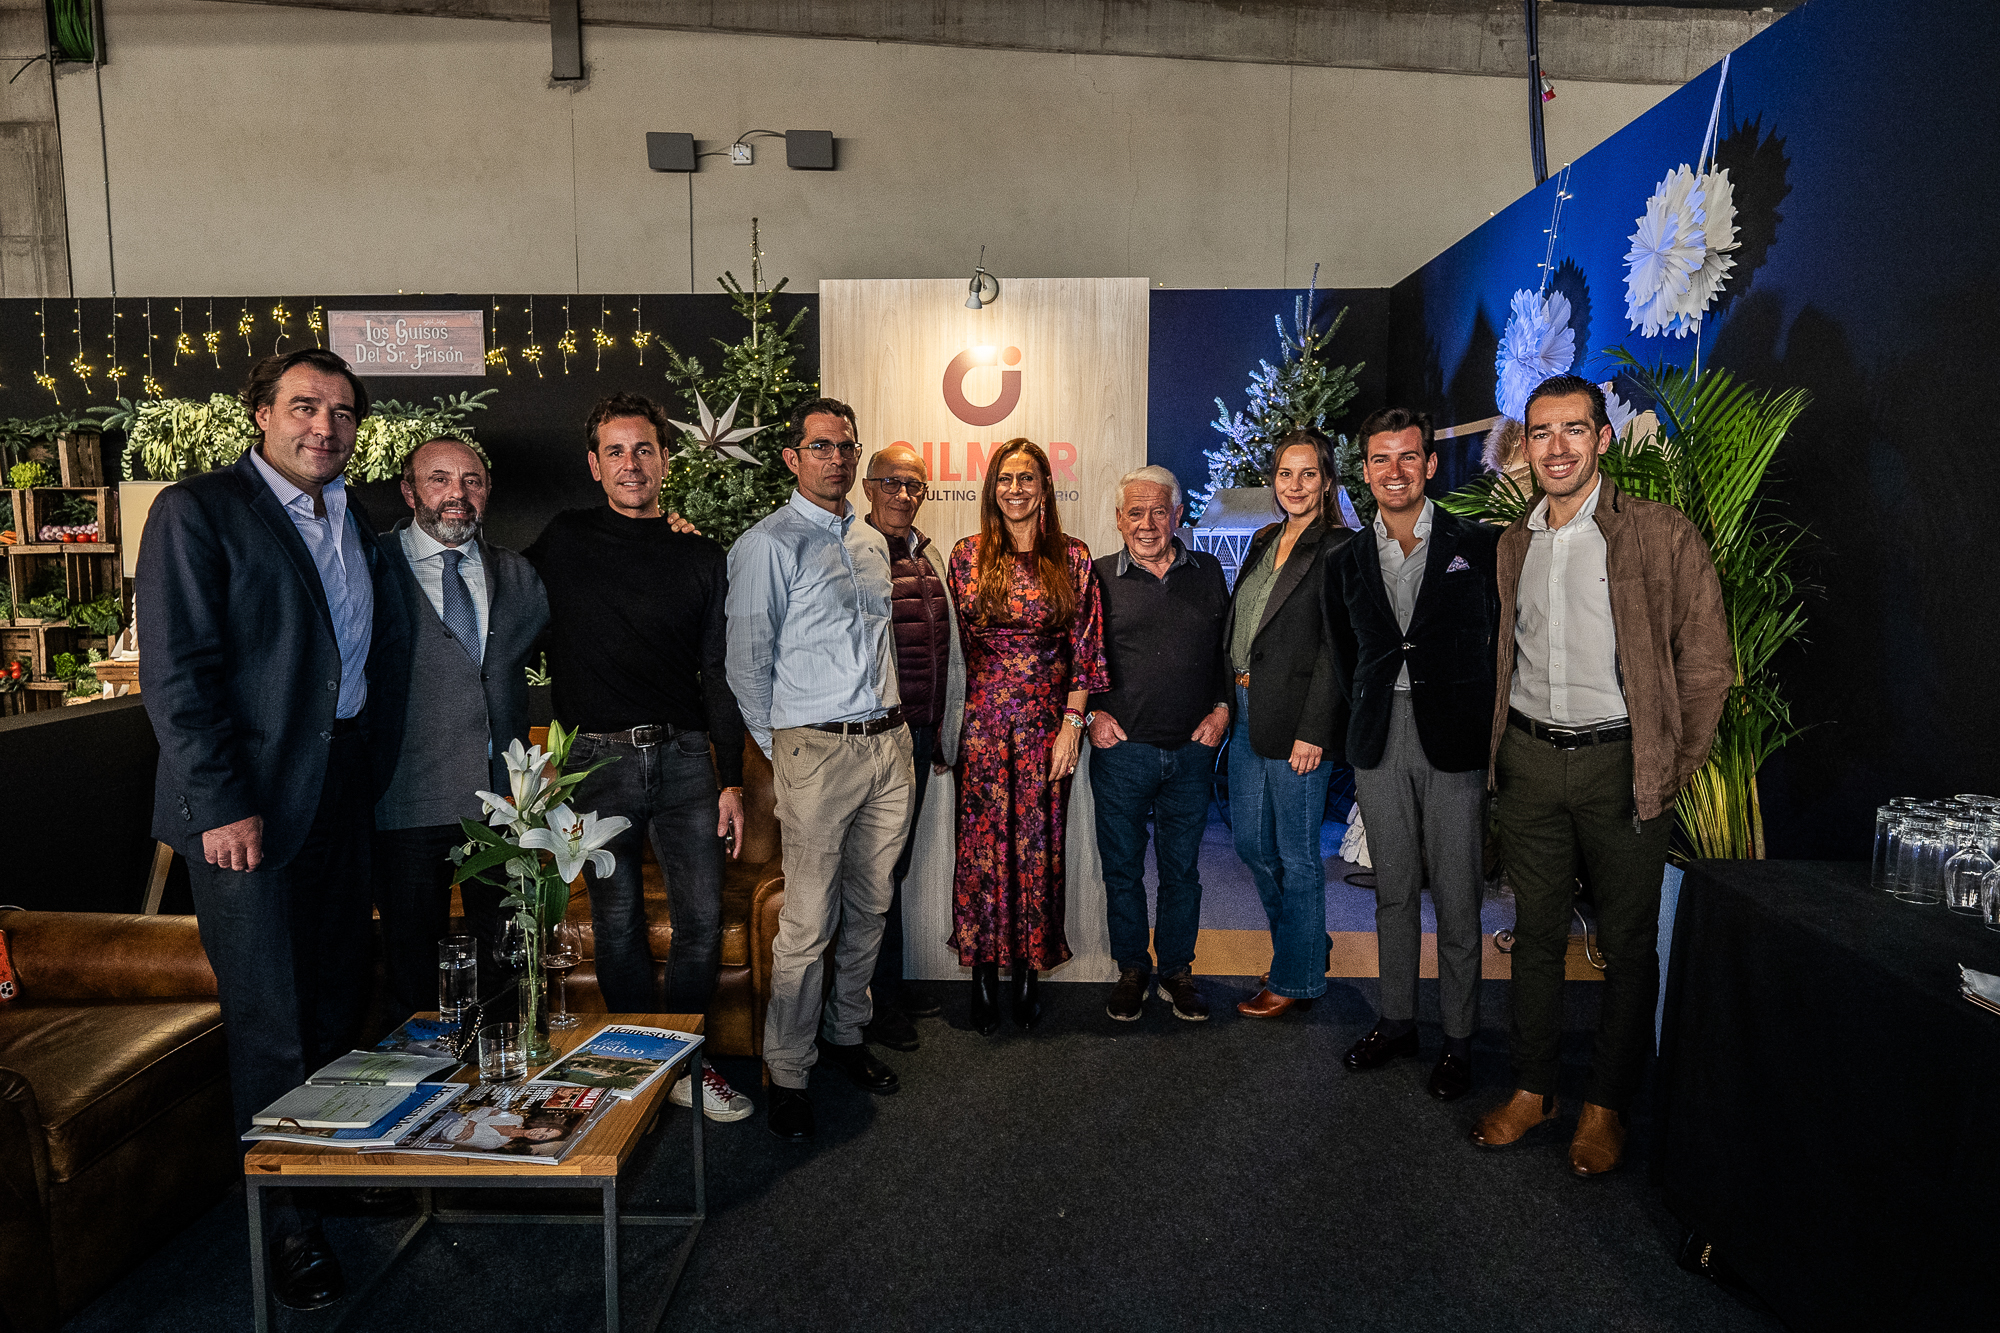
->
[948, 536, 1110, 969]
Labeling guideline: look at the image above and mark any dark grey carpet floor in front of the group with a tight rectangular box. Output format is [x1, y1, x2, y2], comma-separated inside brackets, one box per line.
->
[68, 979, 1778, 1333]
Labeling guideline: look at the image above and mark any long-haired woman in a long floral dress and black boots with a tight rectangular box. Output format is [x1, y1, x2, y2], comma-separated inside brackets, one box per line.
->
[948, 440, 1110, 1035]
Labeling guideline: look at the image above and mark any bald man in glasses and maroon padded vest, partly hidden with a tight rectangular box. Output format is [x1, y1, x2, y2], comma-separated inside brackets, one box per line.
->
[862, 444, 966, 1051]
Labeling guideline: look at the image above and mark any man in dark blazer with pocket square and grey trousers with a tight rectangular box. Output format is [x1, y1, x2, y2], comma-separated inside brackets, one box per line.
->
[1328, 408, 1500, 1101]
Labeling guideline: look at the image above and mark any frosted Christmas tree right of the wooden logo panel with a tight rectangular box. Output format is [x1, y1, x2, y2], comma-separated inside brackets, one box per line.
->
[1188, 264, 1362, 520]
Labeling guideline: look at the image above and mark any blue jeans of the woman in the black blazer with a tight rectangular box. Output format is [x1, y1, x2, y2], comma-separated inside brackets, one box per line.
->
[1230, 687, 1332, 999]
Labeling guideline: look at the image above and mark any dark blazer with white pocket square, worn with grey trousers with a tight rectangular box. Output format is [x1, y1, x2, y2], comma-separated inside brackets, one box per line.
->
[1328, 508, 1500, 773]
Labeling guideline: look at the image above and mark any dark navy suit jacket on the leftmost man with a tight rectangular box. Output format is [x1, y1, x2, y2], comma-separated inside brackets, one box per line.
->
[138, 454, 410, 871]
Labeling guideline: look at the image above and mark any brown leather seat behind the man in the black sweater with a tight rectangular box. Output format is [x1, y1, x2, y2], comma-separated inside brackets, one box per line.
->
[472, 733, 784, 1055]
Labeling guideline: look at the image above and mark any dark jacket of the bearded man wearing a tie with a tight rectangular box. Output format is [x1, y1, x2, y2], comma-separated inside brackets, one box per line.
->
[368, 518, 548, 793]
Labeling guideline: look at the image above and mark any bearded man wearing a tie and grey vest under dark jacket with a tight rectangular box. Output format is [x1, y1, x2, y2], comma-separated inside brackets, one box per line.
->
[374, 438, 548, 1015]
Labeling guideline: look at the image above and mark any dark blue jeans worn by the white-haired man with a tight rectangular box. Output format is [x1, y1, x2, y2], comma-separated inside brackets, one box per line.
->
[1090, 741, 1216, 977]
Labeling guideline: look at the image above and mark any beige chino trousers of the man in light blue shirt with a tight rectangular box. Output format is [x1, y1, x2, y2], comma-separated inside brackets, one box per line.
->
[764, 727, 916, 1087]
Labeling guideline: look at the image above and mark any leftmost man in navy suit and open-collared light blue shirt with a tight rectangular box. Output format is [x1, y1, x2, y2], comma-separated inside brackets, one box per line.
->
[138, 348, 408, 1309]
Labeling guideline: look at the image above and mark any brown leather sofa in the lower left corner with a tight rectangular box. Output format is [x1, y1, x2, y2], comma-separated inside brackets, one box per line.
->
[0, 911, 242, 1333]
